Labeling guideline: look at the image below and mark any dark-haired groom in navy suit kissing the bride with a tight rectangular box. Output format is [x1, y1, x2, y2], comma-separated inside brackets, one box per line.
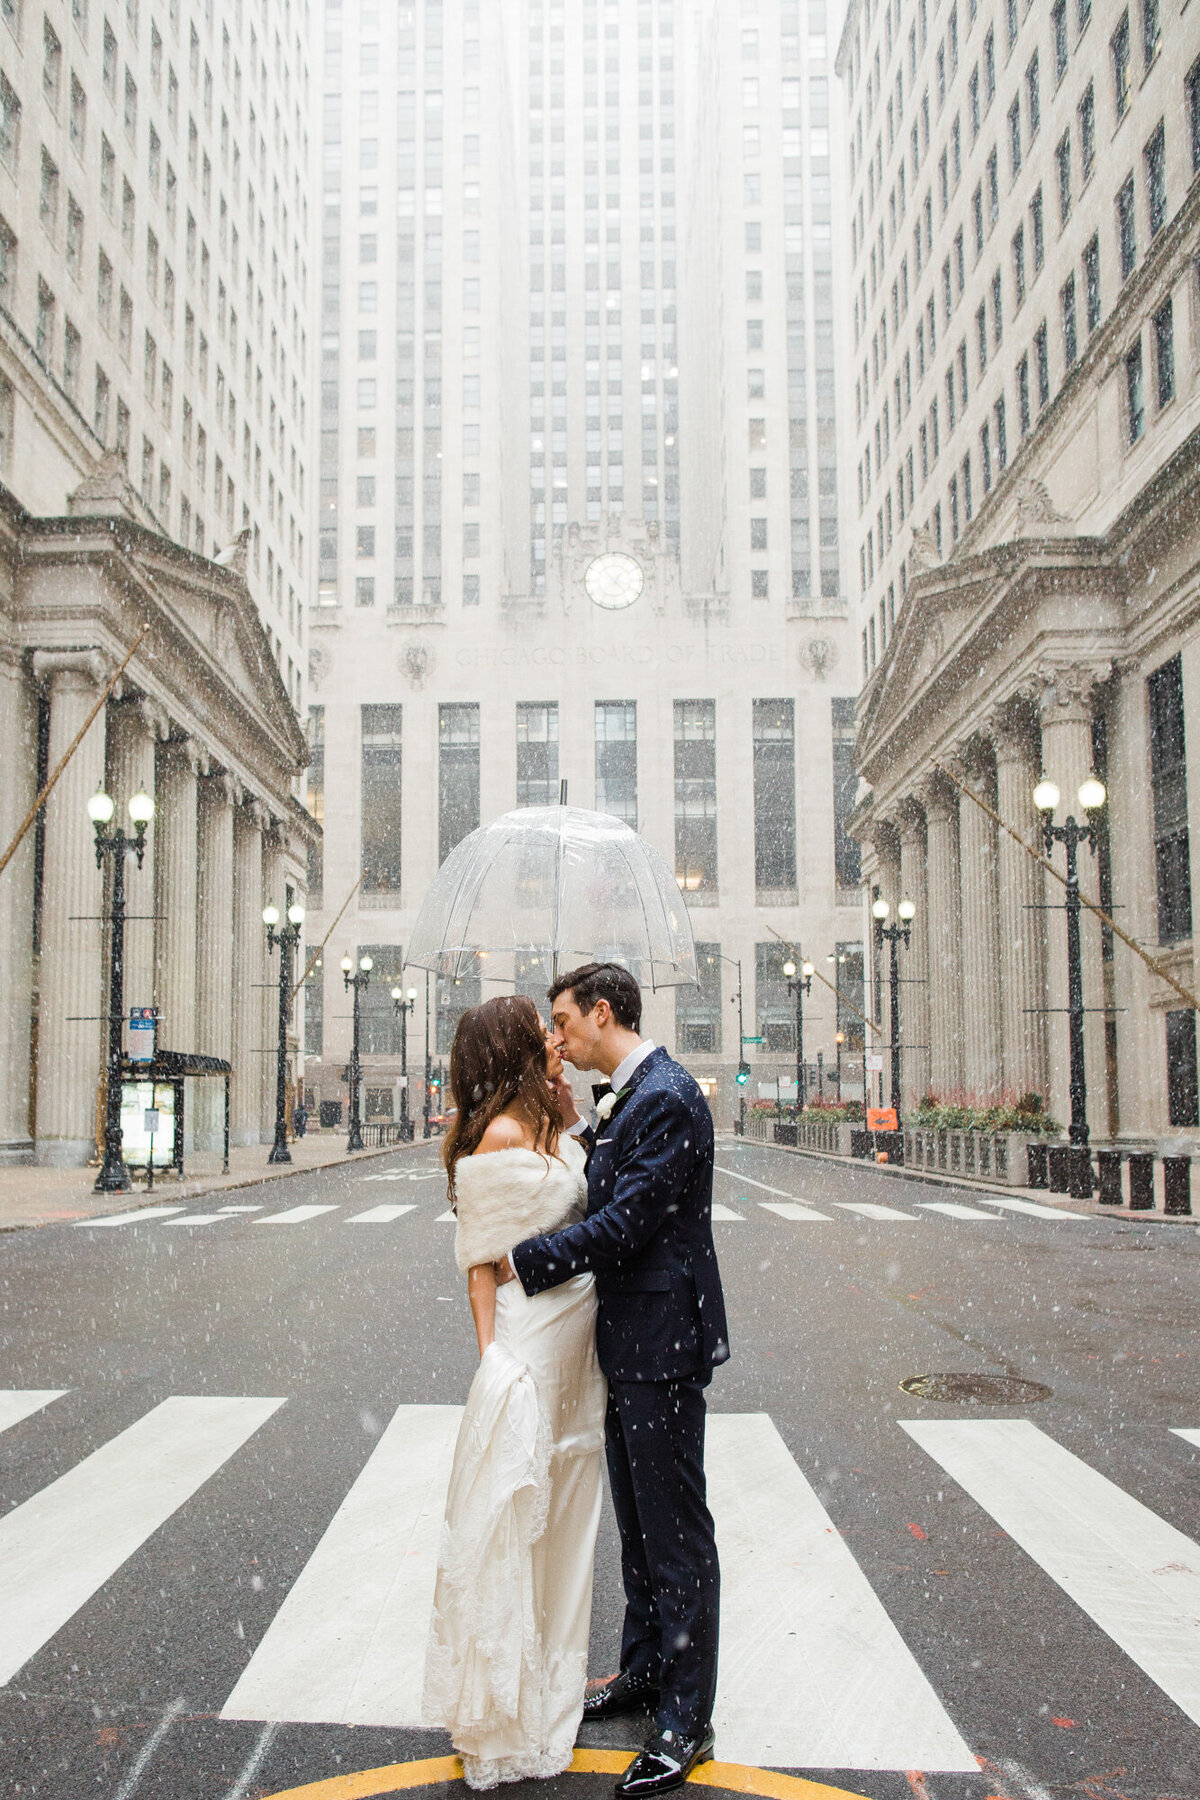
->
[498, 963, 729, 1800]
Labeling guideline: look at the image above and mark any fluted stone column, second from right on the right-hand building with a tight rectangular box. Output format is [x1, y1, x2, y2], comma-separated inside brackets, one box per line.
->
[988, 707, 1047, 1098]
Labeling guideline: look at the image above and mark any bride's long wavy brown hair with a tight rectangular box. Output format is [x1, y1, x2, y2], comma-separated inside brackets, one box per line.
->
[443, 994, 560, 1202]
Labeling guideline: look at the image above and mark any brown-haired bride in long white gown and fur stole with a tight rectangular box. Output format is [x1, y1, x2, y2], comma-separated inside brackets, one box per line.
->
[425, 995, 606, 1787]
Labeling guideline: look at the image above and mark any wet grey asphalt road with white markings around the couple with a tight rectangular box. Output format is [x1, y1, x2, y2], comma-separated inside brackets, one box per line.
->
[0, 1139, 1200, 1800]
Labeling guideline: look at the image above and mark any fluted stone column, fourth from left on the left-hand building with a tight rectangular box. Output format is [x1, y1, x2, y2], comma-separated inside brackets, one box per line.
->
[193, 774, 241, 1150]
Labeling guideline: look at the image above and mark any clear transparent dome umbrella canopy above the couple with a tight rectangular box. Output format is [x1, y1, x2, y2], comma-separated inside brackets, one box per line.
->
[407, 806, 696, 988]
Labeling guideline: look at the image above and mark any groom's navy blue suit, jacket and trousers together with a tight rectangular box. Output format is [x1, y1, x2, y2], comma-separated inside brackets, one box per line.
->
[511, 1049, 729, 1735]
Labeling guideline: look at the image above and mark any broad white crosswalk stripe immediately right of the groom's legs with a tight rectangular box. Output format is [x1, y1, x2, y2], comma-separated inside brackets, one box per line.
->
[705, 1413, 979, 1775]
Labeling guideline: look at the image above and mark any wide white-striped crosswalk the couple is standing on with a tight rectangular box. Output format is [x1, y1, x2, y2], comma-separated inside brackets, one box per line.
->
[0, 1390, 1200, 1775]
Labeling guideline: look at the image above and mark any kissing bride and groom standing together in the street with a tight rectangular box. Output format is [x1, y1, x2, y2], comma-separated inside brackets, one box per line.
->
[425, 963, 729, 1800]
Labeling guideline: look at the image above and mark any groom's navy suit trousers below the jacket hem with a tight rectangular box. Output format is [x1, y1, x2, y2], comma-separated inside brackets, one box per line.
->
[604, 1381, 720, 1735]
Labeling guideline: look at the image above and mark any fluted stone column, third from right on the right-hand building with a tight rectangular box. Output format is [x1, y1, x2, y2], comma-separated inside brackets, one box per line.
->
[959, 743, 1002, 1107]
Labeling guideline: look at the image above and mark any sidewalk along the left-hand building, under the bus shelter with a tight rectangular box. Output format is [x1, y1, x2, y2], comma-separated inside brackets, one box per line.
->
[0, 1132, 431, 1231]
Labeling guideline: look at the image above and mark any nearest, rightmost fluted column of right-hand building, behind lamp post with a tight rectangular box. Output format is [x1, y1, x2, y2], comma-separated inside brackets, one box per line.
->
[1040, 666, 1108, 1138]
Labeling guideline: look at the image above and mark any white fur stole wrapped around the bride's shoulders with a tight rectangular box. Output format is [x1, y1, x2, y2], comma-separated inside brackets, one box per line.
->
[453, 1134, 588, 1274]
